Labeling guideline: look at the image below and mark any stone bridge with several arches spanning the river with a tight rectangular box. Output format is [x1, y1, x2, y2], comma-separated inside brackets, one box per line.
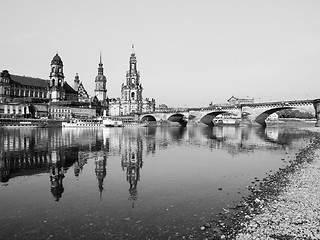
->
[140, 99, 320, 126]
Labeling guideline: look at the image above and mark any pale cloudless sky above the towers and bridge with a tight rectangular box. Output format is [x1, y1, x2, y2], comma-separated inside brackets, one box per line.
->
[0, 0, 320, 107]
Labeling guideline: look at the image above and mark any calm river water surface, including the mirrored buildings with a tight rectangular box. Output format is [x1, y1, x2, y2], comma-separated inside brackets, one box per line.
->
[0, 126, 310, 239]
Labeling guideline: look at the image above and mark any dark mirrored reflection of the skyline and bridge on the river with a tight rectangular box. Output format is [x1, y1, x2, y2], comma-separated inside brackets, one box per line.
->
[0, 127, 308, 187]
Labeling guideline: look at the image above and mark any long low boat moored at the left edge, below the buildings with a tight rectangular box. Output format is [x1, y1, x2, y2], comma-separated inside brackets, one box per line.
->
[0, 118, 48, 128]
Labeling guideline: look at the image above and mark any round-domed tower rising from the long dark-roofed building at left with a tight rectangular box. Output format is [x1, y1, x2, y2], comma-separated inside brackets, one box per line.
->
[49, 53, 65, 102]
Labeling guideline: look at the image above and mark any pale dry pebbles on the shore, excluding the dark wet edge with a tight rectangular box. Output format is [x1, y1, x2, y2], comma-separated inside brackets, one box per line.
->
[235, 135, 320, 240]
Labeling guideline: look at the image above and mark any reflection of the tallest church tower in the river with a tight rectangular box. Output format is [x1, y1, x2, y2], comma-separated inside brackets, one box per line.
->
[121, 135, 143, 207]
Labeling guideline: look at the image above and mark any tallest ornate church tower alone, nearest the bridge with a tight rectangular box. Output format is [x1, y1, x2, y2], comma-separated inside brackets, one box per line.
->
[121, 45, 143, 115]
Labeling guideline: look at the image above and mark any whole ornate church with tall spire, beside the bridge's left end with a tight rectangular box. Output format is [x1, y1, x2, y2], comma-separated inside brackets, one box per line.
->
[109, 46, 155, 116]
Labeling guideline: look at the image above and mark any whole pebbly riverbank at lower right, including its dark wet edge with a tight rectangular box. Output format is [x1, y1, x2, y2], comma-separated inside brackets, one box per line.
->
[203, 127, 320, 240]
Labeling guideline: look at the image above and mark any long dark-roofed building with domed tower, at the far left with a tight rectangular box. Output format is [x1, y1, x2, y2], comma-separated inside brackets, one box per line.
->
[0, 53, 92, 118]
